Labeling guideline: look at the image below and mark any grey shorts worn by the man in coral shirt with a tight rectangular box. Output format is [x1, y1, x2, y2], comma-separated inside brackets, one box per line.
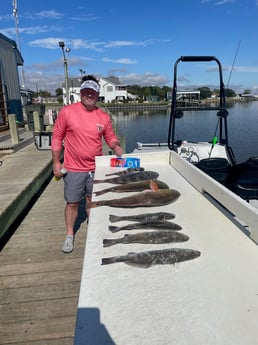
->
[64, 171, 94, 202]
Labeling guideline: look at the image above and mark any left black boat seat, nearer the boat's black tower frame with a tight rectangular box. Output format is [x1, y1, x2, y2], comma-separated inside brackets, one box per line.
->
[196, 157, 231, 184]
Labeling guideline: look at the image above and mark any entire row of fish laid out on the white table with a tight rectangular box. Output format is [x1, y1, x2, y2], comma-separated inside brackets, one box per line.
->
[93, 169, 201, 268]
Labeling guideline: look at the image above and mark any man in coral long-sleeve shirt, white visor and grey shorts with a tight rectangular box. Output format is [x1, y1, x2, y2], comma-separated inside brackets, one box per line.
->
[51, 75, 123, 253]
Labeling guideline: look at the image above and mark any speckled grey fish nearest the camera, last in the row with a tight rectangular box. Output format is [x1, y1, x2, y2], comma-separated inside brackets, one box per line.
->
[101, 248, 201, 268]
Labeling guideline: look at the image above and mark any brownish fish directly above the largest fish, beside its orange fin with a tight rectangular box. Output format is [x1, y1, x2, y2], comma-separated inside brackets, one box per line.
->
[94, 180, 169, 196]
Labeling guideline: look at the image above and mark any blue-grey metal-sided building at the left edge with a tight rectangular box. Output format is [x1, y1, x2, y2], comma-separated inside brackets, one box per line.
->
[0, 33, 23, 126]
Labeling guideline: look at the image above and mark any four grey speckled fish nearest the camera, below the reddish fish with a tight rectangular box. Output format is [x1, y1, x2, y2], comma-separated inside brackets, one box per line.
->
[101, 212, 201, 268]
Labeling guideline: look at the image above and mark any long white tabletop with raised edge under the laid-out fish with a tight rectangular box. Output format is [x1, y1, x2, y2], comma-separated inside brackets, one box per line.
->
[74, 151, 258, 345]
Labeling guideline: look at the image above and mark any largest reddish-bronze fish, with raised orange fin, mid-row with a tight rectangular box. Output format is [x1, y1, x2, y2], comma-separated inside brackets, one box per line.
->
[88, 189, 180, 208]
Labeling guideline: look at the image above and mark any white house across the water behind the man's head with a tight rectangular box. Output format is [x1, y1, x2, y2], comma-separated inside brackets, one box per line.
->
[63, 77, 129, 103]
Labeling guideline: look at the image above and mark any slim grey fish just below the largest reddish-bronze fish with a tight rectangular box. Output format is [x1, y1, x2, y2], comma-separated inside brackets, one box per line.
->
[109, 212, 176, 223]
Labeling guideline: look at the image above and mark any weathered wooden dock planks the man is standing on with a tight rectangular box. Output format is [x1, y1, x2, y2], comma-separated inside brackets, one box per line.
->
[0, 176, 87, 345]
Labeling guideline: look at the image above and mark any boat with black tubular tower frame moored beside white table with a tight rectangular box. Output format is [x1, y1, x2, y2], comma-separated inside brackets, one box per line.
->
[134, 56, 258, 204]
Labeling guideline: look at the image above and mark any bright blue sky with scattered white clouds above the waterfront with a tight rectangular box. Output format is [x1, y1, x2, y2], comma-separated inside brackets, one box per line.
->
[0, 0, 258, 94]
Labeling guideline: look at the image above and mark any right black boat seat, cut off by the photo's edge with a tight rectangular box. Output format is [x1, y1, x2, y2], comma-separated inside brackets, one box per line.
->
[226, 157, 258, 201]
